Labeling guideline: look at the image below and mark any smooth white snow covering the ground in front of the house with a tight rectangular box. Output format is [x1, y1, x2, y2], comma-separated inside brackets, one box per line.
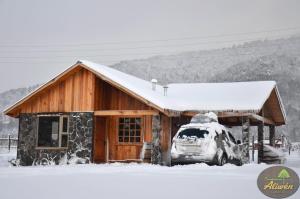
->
[0, 154, 300, 199]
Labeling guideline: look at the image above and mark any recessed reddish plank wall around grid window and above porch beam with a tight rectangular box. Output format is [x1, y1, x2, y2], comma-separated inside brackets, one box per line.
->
[95, 78, 152, 160]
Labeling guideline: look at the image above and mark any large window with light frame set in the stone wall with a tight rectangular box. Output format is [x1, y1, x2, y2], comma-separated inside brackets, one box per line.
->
[37, 116, 69, 148]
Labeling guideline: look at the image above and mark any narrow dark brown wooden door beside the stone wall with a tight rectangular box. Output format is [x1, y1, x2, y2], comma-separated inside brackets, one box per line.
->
[93, 117, 106, 163]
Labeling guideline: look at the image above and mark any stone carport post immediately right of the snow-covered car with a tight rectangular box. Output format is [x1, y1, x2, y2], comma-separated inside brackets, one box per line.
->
[242, 117, 250, 164]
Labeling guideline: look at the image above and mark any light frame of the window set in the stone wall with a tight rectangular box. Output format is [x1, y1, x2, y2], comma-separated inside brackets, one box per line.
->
[35, 114, 70, 150]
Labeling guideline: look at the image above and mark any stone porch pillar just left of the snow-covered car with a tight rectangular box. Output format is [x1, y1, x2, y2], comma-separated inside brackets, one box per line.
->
[151, 115, 162, 164]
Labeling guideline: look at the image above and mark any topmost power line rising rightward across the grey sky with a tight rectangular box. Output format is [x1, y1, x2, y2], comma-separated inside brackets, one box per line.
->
[0, 27, 300, 47]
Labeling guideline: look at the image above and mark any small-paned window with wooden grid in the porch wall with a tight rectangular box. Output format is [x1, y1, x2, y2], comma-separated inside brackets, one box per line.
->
[119, 117, 142, 143]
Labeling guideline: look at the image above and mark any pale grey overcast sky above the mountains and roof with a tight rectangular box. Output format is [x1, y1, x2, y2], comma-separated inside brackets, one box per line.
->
[0, 0, 300, 92]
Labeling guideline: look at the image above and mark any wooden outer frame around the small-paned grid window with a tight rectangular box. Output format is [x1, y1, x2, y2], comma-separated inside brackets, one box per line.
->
[116, 116, 145, 146]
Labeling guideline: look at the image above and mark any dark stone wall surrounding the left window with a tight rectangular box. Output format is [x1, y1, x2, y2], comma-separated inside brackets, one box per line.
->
[17, 113, 93, 166]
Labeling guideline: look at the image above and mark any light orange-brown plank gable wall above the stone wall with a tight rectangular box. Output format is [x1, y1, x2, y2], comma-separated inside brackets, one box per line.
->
[20, 69, 95, 113]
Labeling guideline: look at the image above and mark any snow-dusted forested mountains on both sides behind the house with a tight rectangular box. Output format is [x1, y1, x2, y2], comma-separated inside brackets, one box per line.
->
[0, 36, 300, 141]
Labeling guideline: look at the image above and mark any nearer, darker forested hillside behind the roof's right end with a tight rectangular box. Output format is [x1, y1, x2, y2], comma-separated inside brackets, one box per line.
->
[212, 54, 300, 140]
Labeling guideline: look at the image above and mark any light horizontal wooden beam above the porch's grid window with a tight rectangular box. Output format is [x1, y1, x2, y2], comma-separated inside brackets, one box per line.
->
[94, 110, 159, 116]
